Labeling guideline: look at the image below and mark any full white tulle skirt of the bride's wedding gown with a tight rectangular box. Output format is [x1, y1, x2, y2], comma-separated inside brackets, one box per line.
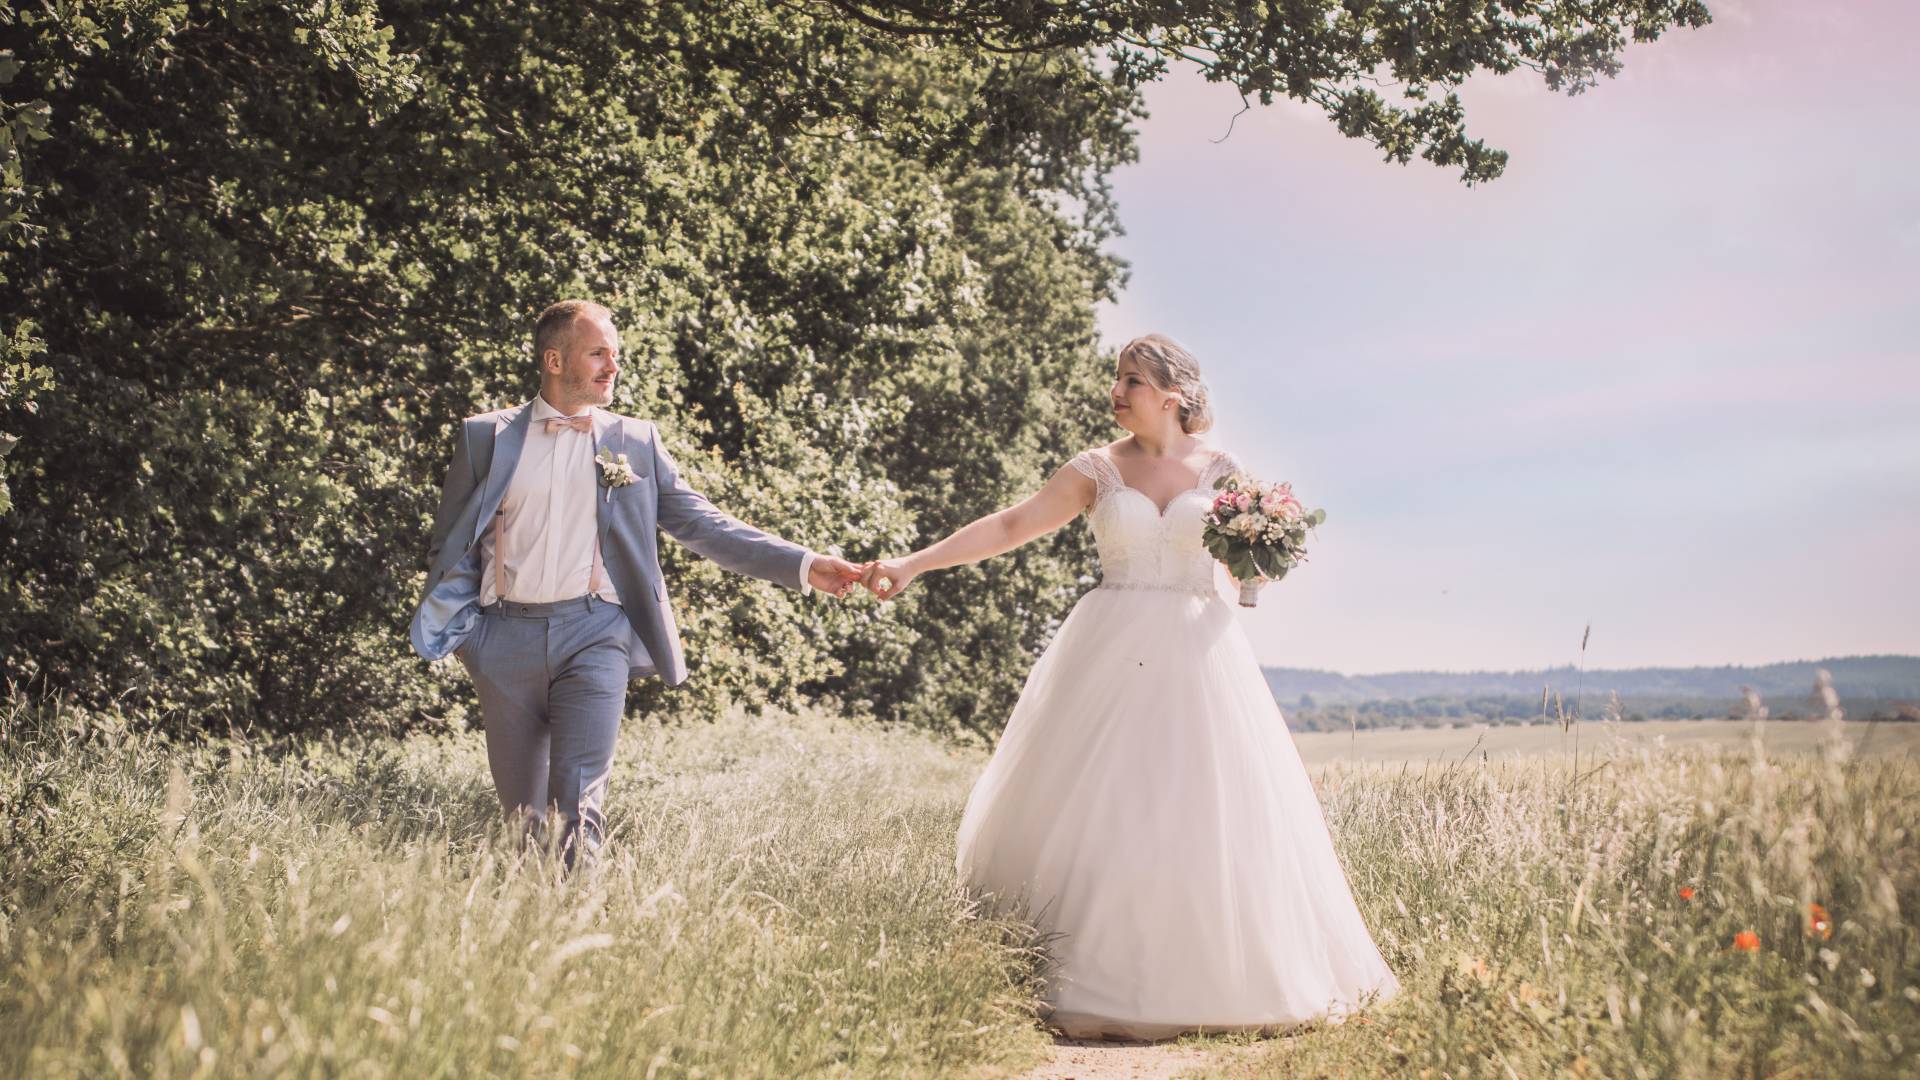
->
[958, 588, 1398, 1040]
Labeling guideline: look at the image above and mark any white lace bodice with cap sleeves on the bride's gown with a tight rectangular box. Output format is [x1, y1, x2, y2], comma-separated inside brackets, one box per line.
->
[1069, 450, 1240, 592]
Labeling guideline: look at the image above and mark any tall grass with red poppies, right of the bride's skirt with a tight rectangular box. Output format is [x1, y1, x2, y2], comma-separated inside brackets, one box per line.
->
[1208, 703, 1920, 1078]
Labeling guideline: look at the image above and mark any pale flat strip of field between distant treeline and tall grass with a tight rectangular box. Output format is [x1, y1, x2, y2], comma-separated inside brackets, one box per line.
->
[1294, 721, 1920, 767]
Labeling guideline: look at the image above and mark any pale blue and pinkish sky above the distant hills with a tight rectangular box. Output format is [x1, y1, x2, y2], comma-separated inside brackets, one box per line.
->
[1100, 0, 1920, 673]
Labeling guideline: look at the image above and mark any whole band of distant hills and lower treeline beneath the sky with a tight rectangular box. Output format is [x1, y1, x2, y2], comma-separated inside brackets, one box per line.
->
[1265, 655, 1920, 730]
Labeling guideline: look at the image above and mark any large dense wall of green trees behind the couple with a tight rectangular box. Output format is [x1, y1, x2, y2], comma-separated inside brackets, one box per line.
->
[0, 0, 1712, 732]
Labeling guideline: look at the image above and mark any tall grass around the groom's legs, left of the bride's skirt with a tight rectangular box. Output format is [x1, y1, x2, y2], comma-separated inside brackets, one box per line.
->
[0, 701, 1044, 1076]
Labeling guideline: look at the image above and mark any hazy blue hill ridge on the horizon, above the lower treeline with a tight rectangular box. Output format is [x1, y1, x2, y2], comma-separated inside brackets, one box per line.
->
[1263, 655, 1920, 713]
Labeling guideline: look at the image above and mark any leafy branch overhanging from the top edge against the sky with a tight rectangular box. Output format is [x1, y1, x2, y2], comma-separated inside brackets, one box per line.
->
[818, 0, 1711, 183]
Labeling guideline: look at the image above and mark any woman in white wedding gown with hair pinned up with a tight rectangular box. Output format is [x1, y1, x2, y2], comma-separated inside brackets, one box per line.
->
[866, 334, 1398, 1040]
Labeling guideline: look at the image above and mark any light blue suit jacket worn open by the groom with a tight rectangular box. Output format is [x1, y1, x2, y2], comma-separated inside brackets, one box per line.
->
[411, 402, 806, 686]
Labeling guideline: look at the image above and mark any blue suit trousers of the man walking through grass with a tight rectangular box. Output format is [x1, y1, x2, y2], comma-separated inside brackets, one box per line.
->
[455, 596, 628, 869]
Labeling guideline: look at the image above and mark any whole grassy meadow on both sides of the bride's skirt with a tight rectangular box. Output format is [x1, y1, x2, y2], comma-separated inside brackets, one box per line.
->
[0, 691, 1920, 1076]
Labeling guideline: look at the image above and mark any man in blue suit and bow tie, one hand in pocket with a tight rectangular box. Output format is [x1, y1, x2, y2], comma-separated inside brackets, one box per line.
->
[411, 300, 862, 869]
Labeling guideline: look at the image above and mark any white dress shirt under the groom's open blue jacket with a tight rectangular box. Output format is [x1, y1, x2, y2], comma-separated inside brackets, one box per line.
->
[480, 396, 814, 607]
